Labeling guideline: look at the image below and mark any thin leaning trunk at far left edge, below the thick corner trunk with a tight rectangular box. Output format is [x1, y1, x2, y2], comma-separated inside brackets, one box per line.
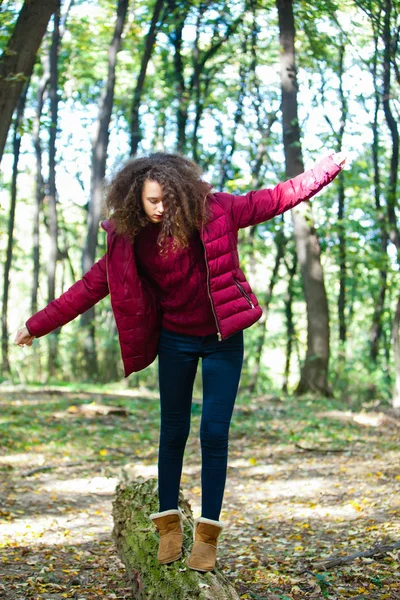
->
[1, 81, 29, 375]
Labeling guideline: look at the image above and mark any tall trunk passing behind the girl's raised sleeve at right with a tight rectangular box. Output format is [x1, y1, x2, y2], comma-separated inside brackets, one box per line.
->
[277, 0, 331, 395]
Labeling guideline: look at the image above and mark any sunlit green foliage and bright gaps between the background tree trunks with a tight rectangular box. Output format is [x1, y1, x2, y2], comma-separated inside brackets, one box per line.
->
[0, 0, 398, 402]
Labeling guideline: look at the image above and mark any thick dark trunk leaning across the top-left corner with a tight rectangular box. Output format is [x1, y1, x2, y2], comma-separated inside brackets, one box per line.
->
[0, 0, 57, 162]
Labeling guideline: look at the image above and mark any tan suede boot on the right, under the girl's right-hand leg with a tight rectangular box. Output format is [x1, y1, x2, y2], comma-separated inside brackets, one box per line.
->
[187, 517, 224, 573]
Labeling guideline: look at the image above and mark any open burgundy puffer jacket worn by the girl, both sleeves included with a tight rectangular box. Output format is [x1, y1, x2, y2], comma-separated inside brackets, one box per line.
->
[26, 157, 341, 377]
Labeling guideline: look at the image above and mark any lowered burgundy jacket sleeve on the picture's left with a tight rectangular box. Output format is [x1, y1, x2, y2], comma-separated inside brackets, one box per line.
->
[25, 255, 109, 337]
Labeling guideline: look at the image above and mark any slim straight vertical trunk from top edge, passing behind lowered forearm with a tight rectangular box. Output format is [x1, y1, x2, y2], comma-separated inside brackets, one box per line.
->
[47, 0, 60, 377]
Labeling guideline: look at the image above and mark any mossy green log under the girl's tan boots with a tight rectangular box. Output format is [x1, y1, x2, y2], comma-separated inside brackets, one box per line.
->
[112, 478, 239, 600]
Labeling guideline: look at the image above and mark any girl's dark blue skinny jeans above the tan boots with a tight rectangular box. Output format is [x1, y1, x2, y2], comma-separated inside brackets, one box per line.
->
[158, 328, 243, 520]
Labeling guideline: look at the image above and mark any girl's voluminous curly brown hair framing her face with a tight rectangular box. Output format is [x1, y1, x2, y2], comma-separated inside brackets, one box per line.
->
[105, 152, 212, 251]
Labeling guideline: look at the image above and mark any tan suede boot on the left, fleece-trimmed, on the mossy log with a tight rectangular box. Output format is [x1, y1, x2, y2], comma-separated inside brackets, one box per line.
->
[150, 508, 183, 565]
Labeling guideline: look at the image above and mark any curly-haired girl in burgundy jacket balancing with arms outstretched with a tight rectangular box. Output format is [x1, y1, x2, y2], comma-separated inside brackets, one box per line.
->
[15, 153, 345, 572]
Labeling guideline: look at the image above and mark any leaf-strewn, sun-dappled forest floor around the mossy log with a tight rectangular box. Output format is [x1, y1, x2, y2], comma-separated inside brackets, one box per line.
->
[0, 386, 400, 600]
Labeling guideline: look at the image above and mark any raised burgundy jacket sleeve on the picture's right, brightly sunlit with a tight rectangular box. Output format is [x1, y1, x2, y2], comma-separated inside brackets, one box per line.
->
[215, 156, 341, 229]
